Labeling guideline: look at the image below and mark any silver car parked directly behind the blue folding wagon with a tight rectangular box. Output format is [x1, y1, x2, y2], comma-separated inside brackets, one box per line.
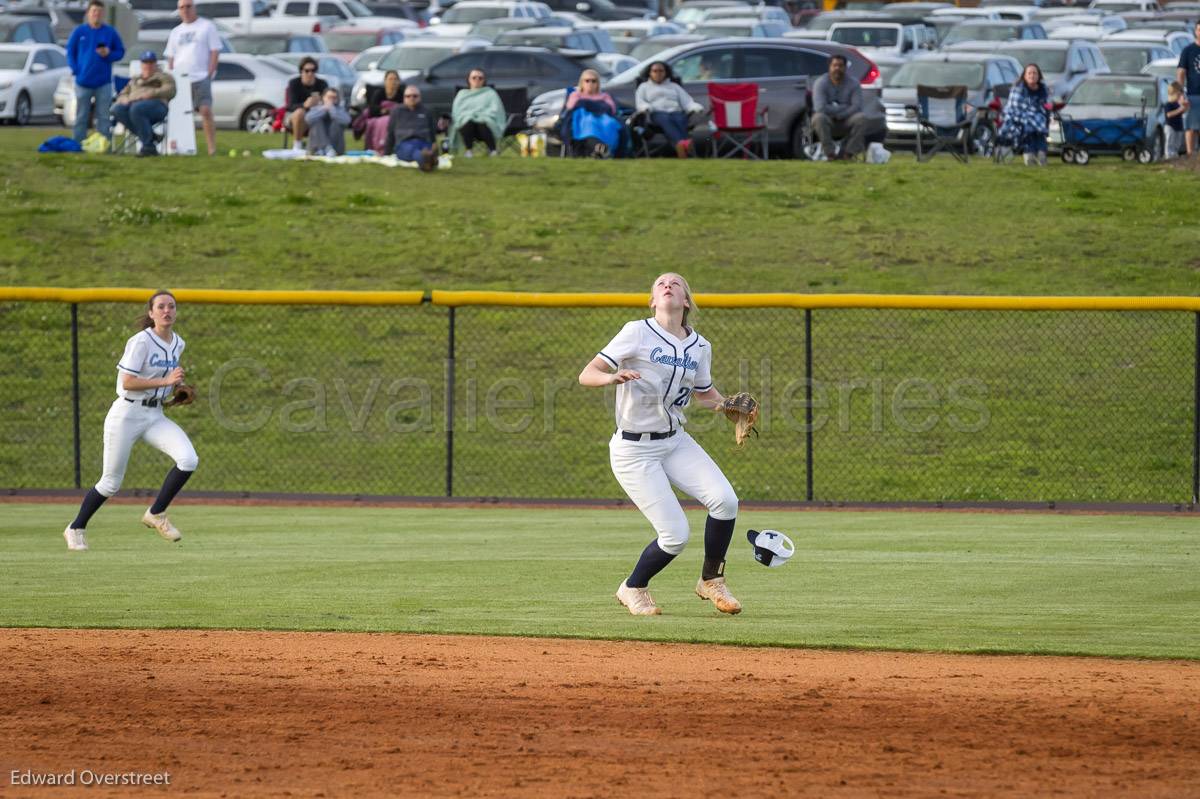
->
[1048, 74, 1168, 161]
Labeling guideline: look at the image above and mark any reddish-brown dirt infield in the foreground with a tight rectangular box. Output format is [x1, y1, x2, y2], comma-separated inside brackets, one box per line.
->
[0, 630, 1200, 799]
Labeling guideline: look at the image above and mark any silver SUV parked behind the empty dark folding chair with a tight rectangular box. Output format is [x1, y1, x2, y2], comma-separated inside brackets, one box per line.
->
[883, 53, 1021, 154]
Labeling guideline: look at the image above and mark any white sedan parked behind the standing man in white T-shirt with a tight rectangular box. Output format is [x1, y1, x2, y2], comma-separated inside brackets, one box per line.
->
[54, 53, 295, 131]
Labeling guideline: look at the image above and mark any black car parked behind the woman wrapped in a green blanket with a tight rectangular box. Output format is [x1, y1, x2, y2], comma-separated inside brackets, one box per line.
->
[384, 47, 590, 114]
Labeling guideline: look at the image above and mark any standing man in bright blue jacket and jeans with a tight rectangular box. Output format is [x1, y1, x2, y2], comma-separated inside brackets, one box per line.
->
[67, 0, 125, 142]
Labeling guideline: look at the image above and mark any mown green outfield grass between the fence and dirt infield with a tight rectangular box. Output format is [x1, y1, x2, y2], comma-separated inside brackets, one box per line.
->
[0, 504, 1200, 659]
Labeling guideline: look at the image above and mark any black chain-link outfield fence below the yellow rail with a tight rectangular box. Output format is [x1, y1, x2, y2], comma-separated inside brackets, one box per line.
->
[0, 302, 1200, 503]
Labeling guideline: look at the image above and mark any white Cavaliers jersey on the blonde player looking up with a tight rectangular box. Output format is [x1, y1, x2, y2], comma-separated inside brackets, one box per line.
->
[600, 319, 713, 433]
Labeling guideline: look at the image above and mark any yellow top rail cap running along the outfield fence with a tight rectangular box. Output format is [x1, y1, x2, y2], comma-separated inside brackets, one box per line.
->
[0, 287, 1200, 312]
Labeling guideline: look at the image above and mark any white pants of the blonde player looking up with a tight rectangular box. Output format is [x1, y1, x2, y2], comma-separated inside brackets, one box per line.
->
[608, 429, 738, 554]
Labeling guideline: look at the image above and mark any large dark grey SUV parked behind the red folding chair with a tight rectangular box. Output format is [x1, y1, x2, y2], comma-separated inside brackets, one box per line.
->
[526, 38, 886, 157]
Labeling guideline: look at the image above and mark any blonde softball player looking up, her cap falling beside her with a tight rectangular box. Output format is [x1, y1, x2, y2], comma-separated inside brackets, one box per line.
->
[580, 272, 742, 615]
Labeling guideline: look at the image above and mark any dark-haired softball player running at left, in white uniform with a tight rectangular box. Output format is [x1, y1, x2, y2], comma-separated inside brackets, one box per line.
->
[62, 292, 198, 551]
